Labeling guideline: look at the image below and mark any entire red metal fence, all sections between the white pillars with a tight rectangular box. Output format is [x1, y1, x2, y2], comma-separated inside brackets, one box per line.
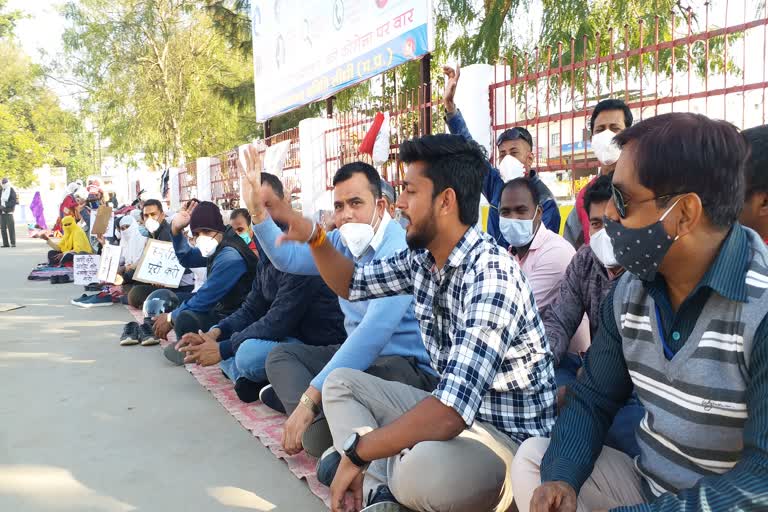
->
[179, 2, 768, 206]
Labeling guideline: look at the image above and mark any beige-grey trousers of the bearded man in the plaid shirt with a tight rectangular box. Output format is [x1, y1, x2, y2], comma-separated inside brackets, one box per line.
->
[323, 368, 517, 512]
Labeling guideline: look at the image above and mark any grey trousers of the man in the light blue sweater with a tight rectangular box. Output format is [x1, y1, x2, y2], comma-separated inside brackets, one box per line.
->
[266, 343, 438, 416]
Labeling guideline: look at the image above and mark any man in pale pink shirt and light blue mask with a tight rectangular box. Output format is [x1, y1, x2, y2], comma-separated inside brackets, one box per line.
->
[499, 178, 575, 307]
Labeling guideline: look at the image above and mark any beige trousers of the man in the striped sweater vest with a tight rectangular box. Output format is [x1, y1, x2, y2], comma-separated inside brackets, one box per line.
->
[512, 437, 645, 512]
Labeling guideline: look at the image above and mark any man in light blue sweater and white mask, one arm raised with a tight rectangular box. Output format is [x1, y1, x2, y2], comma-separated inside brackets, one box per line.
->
[244, 155, 437, 464]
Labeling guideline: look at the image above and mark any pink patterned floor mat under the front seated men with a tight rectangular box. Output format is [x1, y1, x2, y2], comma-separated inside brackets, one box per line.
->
[127, 306, 331, 508]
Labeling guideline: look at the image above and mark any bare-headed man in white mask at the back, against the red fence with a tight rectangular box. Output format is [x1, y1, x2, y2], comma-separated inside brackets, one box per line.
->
[563, 98, 633, 249]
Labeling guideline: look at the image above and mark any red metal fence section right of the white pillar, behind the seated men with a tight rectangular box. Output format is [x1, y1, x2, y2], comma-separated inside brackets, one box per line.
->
[489, 3, 768, 192]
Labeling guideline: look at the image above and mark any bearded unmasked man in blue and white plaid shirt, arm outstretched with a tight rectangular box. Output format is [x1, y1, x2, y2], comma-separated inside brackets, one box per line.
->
[273, 135, 555, 512]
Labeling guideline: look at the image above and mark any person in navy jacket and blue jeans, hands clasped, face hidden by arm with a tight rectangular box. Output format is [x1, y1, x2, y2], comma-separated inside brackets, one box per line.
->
[176, 173, 346, 402]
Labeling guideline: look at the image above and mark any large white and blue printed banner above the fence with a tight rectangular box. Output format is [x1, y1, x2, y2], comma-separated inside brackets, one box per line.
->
[251, 0, 434, 122]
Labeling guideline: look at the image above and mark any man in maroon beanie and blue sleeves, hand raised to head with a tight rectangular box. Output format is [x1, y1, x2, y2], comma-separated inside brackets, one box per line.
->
[154, 201, 258, 365]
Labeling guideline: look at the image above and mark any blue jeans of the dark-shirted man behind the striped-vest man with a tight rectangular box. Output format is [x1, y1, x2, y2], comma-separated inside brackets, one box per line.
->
[555, 353, 645, 457]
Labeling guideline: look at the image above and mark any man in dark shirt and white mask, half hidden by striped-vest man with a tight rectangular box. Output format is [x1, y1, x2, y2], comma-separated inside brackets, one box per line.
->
[539, 173, 644, 457]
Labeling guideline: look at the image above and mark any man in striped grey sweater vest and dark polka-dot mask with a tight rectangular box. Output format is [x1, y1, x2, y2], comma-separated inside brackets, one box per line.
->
[511, 113, 768, 512]
